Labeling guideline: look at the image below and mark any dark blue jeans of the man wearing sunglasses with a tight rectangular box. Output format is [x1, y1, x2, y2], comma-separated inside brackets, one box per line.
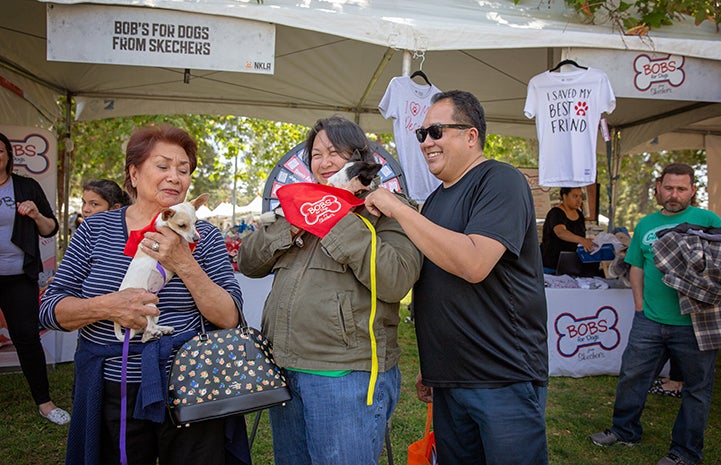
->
[433, 382, 548, 465]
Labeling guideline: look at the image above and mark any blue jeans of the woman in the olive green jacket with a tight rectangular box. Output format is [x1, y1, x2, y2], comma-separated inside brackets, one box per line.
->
[270, 366, 401, 465]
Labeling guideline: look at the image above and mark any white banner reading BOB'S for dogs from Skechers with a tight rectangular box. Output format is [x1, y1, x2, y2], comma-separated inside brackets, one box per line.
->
[47, 5, 275, 74]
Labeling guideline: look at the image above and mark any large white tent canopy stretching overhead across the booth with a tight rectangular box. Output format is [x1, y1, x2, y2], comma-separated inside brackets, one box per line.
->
[0, 0, 721, 217]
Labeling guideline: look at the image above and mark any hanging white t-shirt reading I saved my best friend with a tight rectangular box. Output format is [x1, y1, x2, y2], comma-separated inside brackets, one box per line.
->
[523, 68, 616, 187]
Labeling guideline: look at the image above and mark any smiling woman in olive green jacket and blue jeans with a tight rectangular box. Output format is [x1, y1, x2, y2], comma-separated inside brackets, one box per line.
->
[239, 117, 422, 465]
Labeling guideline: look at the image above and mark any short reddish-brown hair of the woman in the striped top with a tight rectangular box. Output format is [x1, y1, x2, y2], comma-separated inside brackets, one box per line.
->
[123, 123, 198, 198]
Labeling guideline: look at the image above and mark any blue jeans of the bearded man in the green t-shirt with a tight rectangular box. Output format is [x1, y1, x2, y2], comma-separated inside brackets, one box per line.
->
[611, 312, 718, 463]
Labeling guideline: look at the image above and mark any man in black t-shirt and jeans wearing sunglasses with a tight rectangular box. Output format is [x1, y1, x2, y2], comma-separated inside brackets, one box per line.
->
[366, 91, 548, 465]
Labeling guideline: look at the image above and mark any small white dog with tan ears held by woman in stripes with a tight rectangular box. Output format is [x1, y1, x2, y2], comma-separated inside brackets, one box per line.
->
[115, 194, 208, 342]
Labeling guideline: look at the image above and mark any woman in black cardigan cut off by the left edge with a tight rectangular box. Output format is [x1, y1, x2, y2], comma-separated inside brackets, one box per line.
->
[0, 133, 70, 425]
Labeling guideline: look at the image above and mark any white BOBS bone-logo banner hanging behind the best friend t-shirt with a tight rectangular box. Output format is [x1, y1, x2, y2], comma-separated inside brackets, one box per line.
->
[565, 48, 721, 102]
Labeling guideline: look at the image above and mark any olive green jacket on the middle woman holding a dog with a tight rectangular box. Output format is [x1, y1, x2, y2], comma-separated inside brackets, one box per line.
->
[238, 198, 423, 373]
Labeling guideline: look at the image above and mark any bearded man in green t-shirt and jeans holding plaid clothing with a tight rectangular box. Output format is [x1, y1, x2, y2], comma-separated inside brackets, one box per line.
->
[590, 163, 721, 465]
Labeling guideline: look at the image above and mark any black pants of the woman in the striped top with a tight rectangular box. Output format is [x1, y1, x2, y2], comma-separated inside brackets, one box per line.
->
[100, 381, 225, 465]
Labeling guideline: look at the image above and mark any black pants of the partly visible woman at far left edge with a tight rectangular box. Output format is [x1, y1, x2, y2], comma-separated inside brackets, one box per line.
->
[0, 274, 50, 405]
